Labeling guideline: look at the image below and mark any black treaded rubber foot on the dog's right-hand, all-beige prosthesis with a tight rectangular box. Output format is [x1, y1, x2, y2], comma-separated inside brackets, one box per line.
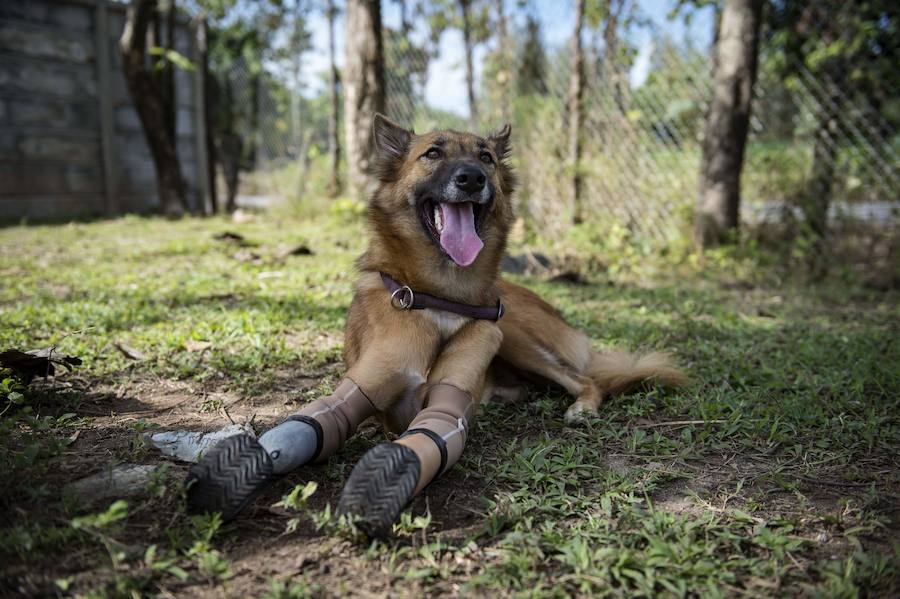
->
[338, 443, 420, 537]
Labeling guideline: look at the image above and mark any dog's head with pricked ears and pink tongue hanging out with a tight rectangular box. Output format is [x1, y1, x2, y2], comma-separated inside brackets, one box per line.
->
[372, 114, 515, 267]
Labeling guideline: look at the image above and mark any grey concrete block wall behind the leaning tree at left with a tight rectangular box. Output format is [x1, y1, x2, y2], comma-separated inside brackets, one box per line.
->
[0, 0, 206, 225]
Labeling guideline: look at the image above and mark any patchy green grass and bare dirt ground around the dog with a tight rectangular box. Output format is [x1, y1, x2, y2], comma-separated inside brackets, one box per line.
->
[0, 213, 900, 597]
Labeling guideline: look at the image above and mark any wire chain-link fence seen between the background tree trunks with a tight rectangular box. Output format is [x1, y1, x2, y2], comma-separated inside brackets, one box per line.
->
[220, 4, 900, 241]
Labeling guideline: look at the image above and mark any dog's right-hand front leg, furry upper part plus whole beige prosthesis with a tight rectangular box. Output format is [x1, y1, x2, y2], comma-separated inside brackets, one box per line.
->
[339, 320, 503, 535]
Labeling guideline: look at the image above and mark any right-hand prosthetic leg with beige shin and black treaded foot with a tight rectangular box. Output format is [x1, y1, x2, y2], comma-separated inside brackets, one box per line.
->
[338, 383, 474, 536]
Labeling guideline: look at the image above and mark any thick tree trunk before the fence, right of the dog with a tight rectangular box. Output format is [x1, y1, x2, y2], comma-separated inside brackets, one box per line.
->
[694, 0, 762, 250]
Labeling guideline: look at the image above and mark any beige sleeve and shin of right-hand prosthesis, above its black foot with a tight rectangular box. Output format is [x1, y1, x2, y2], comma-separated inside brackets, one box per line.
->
[395, 383, 474, 494]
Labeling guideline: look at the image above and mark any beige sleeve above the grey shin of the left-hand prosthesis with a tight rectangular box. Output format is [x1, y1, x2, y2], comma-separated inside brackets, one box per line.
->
[291, 378, 375, 462]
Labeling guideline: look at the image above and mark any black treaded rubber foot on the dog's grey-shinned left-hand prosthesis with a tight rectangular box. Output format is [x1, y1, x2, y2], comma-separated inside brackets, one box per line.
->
[187, 434, 275, 520]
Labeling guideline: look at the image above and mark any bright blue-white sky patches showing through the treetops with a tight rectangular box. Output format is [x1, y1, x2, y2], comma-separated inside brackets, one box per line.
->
[304, 0, 713, 115]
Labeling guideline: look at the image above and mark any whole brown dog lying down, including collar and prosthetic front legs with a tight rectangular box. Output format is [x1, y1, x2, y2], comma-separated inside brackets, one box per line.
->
[189, 115, 686, 533]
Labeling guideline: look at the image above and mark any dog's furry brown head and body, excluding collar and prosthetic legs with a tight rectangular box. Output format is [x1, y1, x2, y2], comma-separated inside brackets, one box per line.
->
[344, 115, 686, 432]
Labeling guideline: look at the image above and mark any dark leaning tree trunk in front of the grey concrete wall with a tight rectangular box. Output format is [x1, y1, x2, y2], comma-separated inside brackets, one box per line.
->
[119, 0, 187, 217]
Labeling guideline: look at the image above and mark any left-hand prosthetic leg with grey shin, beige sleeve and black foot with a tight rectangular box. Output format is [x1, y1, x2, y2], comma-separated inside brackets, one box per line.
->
[187, 378, 375, 520]
